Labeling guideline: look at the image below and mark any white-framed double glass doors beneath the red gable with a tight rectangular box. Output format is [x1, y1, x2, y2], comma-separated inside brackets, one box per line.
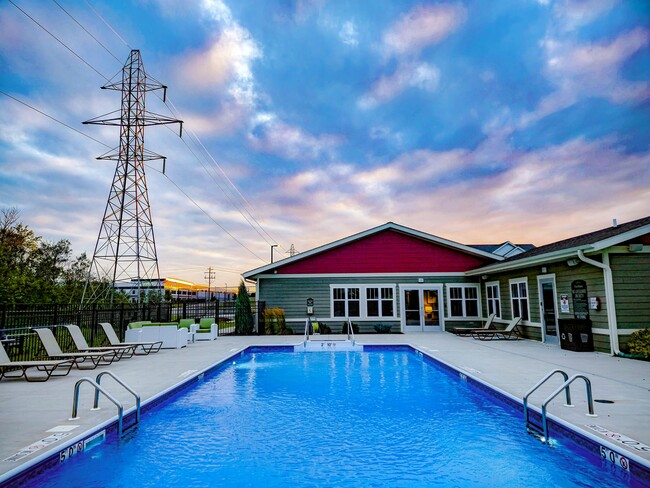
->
[402, 285, 442, 332]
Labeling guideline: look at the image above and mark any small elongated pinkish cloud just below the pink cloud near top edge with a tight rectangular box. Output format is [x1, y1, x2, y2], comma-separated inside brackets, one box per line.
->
[358, 63, 440, 109]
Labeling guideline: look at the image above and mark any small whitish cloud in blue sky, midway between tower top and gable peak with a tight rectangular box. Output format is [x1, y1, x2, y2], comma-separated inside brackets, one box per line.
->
[248, 113, 343, 161]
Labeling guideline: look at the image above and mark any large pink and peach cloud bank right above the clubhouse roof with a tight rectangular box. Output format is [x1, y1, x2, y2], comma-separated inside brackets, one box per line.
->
[259, 133, 650, 255]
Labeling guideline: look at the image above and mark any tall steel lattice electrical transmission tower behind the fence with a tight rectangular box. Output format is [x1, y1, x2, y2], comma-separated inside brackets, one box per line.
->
[82, 49, 183, 305]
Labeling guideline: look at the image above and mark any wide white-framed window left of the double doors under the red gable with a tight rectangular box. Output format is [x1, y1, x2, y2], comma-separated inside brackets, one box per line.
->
[332, 285, 395, 318]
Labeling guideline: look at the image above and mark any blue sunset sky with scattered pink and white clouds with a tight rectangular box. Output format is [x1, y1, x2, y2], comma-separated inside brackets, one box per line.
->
[0, 0, 650, 286]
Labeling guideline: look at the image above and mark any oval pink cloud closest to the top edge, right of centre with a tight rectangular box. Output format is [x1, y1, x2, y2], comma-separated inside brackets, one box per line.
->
[383, 4, 467, 57]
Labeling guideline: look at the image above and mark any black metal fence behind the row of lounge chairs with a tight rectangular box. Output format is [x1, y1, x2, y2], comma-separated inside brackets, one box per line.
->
[0, 301, 264, 361]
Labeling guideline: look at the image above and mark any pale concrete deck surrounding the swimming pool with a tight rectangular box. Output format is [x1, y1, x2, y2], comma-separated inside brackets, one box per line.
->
[0, 332, 650, 481]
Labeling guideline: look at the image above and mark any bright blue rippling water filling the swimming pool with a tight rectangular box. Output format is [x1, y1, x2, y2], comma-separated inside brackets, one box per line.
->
[21, 351, 628, 488]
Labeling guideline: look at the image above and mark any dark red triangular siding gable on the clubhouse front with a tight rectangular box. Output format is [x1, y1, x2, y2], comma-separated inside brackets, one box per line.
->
[277, 230, 492, 274]
